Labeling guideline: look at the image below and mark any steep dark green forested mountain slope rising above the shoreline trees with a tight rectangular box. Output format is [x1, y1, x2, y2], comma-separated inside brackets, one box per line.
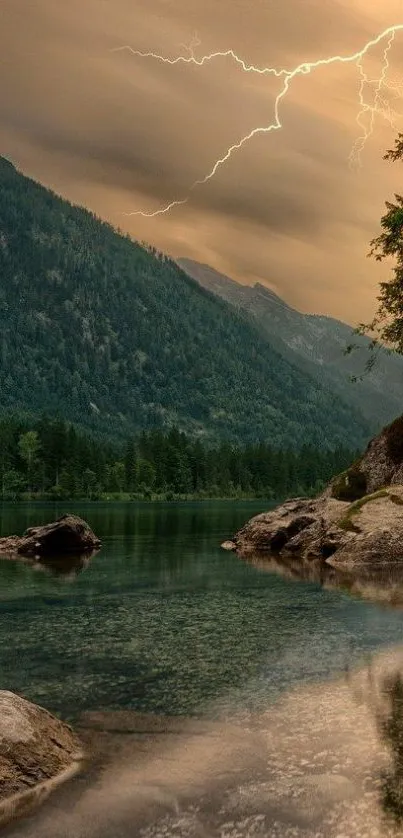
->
[0, 158, 371, 449]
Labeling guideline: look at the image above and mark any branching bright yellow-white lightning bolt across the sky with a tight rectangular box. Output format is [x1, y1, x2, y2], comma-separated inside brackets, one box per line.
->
[112, 23, 403, 218]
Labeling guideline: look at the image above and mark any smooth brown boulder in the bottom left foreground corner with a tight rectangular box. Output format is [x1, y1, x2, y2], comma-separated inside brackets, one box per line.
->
[0, 690, 83, 824]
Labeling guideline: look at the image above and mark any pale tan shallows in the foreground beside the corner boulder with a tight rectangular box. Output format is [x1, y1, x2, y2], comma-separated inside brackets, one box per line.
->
[3, 649, 403, 838]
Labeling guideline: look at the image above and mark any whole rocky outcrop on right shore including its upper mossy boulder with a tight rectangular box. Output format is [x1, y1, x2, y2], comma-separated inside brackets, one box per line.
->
[227, 416, 403, 572]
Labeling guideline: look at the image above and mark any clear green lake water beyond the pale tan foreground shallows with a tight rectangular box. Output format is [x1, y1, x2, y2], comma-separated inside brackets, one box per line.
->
[0, 501, 403, 718]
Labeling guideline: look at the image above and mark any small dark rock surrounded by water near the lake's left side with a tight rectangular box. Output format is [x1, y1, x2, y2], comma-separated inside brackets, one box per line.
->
[0, 515, 101, 559]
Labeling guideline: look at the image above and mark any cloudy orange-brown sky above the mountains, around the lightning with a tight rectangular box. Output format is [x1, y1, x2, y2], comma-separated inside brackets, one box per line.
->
[0, 0, 403, 323]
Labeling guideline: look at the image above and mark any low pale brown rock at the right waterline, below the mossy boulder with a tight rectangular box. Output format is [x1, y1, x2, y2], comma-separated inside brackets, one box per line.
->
[225, 485, 403, 570]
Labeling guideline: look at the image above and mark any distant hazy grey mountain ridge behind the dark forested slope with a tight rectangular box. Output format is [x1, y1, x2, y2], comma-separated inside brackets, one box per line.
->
[178, 259, 403, 432]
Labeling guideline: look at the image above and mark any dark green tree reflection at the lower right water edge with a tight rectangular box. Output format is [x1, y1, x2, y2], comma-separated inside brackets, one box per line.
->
[380, 672, 403, 825]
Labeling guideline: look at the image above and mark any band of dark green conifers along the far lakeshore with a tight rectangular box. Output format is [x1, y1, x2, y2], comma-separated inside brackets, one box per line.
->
[0, 415, 356, 500]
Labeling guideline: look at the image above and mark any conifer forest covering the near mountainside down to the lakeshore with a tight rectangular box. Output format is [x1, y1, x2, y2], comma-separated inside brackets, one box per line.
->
[0, 157, 375, 501]
